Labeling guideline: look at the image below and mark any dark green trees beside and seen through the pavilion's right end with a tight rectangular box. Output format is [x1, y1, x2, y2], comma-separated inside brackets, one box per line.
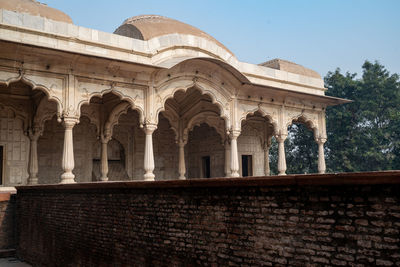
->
[271, 61, 400, 173]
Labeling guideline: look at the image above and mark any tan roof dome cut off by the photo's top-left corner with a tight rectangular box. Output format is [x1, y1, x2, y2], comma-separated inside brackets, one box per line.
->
[0, 0, 72, 23]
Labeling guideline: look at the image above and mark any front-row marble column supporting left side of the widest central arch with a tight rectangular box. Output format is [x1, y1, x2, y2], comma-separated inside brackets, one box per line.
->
[143, 124, 157, 181]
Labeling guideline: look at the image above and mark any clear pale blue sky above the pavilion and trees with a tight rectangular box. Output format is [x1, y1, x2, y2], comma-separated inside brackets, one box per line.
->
[39, 0, 400, 76]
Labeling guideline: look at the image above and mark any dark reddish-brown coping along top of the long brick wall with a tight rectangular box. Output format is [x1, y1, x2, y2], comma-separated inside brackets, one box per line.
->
[16, 170, 400, 192]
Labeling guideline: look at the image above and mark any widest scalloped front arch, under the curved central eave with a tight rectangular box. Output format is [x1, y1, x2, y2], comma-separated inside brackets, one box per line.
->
[155, 76, 230, 129]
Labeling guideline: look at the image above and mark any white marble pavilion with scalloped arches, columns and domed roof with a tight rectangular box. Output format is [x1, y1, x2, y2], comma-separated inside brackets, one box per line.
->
[0, 0, 346, 186]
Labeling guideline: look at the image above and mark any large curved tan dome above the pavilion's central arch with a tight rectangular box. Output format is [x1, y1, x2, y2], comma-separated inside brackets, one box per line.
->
[114, 15, 232, 54]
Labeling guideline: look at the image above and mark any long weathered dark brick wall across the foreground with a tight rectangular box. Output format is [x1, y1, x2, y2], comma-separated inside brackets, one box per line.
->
[17, 172, 400, 266]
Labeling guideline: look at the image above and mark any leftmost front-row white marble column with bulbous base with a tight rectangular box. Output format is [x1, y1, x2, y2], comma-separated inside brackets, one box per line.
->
[60, 117, 78, 184]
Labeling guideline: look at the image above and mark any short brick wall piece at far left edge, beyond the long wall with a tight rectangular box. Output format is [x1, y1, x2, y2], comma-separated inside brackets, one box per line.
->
[0, 193, 15, 250]
